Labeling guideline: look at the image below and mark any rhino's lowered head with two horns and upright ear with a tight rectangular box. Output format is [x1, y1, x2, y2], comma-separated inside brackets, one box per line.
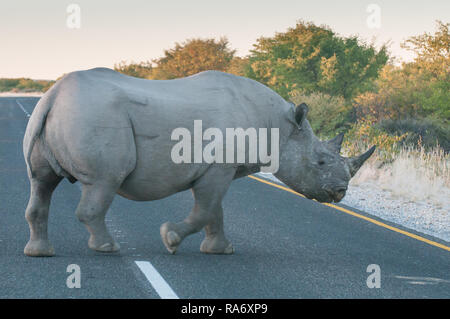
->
[275, 103, 375, 202]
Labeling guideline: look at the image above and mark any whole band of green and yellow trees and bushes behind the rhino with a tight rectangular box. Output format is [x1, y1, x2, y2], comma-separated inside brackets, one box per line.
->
[0, 21, 450, 153]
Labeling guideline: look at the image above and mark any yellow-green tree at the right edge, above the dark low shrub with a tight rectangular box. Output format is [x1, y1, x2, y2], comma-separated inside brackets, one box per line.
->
[354, 21, 450, 121]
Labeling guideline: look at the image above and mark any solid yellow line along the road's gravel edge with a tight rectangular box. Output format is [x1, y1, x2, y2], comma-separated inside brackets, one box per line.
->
[248, 176, 450, 251]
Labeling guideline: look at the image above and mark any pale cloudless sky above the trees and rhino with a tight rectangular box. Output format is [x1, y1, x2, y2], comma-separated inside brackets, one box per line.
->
[0, 0, 450, 79]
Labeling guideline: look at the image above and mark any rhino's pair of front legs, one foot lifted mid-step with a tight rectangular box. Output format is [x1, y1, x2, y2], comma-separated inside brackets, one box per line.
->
[160, 166, 236, 254]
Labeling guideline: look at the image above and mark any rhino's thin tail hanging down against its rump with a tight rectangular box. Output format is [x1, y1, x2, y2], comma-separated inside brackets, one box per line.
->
[23, 88, 55, 177]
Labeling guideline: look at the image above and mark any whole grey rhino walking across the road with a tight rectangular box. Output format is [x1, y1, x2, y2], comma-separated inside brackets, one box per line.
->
[23, 68, 373, 256]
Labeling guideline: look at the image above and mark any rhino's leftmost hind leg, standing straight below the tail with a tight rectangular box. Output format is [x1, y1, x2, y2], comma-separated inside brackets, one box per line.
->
[24, 166, 61, 257]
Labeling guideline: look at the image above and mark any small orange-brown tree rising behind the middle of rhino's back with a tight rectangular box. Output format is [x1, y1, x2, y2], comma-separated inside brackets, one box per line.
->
[151, 38, 235, 80]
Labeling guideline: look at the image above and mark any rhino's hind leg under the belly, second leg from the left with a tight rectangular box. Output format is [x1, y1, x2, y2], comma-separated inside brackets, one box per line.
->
[76, 183, 120, 252]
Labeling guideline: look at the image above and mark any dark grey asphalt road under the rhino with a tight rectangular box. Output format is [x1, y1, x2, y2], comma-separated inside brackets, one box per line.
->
[0, 98, 450, 298]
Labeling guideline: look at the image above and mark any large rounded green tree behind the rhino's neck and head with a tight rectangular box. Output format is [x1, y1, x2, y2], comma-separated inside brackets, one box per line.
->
[246, 22, 388, 100]
